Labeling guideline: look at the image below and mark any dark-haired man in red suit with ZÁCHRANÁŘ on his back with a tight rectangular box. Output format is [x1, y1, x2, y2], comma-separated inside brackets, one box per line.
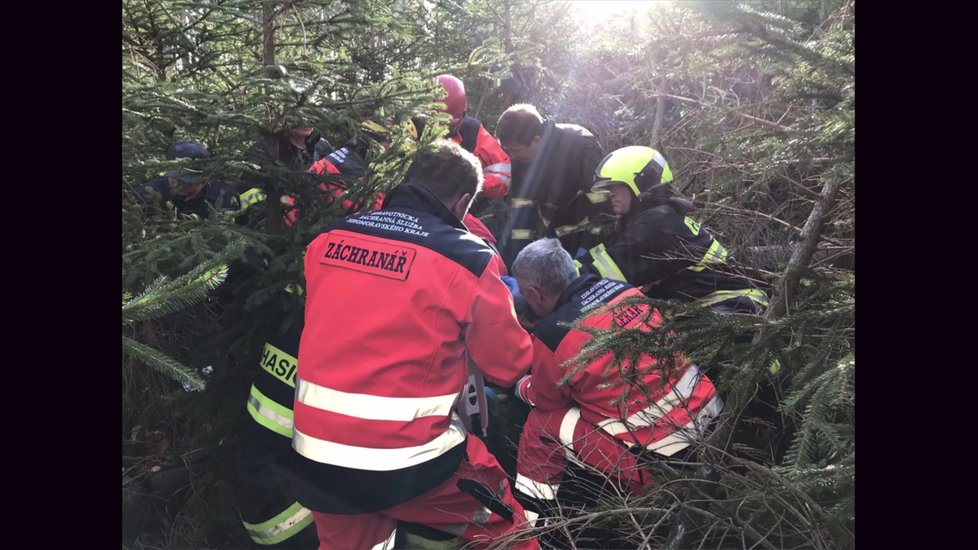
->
[292, 140, 538, 549]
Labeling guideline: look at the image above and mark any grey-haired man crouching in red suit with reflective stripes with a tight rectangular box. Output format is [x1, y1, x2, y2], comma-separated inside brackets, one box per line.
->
[512, 239, 723, 519]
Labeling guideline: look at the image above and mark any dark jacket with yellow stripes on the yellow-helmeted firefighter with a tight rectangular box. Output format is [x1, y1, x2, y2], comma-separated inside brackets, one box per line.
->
[578, 184, 757, 302]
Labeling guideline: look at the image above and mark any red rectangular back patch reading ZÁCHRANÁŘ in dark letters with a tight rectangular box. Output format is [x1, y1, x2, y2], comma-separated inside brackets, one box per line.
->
[319, 235, 417, 281]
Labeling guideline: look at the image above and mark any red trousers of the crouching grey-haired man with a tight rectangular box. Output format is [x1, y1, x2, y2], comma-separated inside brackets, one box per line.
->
[516, 407, 654, 501]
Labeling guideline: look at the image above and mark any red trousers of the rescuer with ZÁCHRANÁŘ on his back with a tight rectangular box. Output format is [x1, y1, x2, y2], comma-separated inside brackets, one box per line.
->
[313, 436, 539, 550]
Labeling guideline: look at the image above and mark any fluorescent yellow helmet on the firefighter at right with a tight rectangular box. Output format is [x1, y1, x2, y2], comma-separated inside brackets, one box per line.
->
[592, 145, 672, 197]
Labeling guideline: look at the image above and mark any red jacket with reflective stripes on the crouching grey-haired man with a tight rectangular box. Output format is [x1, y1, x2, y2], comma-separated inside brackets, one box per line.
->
[527, 275, 722, 455]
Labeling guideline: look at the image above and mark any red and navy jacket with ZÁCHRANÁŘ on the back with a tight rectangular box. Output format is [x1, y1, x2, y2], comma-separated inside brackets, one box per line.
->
[293, 184, 532, 511]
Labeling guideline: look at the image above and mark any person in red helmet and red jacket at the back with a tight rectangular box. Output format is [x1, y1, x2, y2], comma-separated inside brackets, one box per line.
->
[435, 74, 513, 199]
